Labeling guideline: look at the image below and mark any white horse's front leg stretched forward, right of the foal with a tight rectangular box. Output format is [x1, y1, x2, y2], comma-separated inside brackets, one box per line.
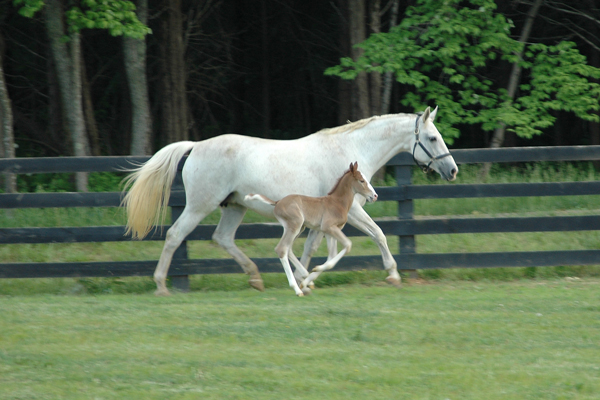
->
[348, 205, 401, 286]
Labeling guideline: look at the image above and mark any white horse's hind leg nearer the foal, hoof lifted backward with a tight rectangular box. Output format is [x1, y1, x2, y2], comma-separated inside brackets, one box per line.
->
[213, 203, 265, 292]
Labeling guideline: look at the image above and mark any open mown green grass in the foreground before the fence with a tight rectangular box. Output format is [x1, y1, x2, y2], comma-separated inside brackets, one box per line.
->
[0, 279, 600, 400]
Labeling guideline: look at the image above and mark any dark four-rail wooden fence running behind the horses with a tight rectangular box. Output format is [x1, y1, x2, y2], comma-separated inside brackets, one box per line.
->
[0, 146, 600, 290]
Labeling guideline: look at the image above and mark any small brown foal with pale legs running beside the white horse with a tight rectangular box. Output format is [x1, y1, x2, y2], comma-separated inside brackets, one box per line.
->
[245, 162, 377, 296]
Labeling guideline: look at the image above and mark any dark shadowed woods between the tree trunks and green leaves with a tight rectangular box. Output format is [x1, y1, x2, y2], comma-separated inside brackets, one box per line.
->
[0, 0, 600, 157]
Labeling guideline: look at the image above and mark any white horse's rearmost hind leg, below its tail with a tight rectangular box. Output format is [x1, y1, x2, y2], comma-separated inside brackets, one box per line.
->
[154, 207, 208, 296]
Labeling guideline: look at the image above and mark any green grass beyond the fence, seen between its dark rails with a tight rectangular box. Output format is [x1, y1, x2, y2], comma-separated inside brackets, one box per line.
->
[0, 163, 600, 293]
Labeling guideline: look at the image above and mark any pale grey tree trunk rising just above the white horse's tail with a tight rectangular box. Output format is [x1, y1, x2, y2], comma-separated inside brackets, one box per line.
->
[123, 0, 152, 156]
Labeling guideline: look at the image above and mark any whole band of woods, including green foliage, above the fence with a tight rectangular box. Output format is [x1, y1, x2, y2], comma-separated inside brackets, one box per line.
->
[0, 0, 600, 161]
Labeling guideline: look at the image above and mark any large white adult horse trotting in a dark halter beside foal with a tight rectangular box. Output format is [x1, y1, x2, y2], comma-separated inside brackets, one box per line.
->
[123, 107, 458, 295]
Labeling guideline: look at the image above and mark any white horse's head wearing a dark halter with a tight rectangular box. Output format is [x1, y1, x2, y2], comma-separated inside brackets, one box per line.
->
[412, 107, 458, 181]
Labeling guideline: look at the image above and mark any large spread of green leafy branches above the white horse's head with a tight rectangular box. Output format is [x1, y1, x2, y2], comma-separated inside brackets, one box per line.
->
[325, 0, 600, 143]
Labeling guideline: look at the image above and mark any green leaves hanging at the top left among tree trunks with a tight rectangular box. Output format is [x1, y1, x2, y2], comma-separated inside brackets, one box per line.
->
[13, 0, 152, 39]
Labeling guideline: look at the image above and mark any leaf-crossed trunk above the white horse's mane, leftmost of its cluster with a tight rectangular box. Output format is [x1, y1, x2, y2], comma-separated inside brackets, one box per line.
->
[348, 0, 371, 120]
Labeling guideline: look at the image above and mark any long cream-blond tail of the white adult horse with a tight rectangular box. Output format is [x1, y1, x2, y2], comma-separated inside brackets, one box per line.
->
[121, 142, 195, 239]
